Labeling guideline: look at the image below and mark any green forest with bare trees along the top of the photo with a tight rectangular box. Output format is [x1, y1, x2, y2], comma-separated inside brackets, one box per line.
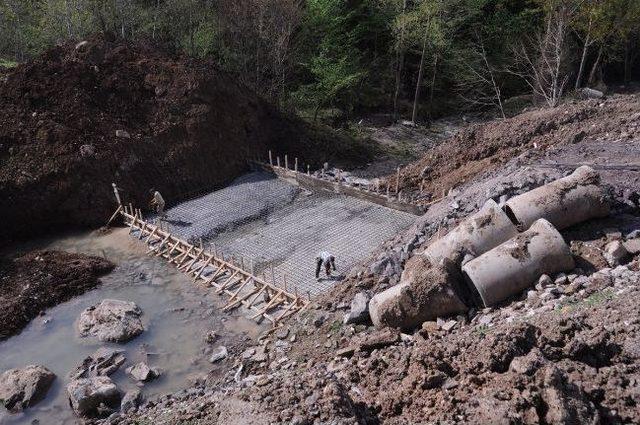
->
[0, 0, 640, 123]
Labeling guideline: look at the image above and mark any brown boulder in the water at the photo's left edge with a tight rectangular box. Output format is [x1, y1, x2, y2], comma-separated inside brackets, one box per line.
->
[0, 365, 56, 412]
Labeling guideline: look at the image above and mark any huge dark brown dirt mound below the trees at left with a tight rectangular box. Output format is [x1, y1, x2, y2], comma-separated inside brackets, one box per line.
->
[0, 36, 368, 240]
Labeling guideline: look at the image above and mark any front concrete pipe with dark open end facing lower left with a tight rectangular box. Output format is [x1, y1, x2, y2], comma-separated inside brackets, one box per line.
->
[462, 219, 575, 307]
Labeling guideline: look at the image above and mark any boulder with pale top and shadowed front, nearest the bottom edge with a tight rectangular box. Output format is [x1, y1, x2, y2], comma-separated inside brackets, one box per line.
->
[67, 376, 120, 417]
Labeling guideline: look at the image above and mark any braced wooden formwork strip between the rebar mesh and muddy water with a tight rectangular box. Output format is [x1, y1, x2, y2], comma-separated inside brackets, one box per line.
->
[117, 205, 310, 327]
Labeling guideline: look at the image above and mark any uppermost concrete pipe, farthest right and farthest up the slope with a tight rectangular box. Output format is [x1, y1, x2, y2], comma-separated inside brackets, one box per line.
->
[504, 166, 609, 229]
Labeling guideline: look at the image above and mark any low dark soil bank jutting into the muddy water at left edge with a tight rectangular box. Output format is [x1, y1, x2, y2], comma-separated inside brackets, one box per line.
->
[0, 251, 114, 341]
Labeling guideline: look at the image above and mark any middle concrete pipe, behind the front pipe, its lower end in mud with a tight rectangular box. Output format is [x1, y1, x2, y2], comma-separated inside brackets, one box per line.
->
[424, 199, 518, 265]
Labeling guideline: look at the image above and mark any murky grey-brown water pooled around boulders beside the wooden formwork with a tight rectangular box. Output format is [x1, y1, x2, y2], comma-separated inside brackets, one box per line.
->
[0, 229, 264, 424]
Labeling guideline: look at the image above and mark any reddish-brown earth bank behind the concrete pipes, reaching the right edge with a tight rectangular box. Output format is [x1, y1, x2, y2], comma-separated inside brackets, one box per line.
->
[398, 95, 640, 203]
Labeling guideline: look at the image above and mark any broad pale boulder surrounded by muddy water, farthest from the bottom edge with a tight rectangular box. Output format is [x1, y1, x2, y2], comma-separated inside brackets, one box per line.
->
[78, 300, 144, 342]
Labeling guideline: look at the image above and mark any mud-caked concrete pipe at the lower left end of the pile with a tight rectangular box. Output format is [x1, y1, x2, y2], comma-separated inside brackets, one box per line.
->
[369, 255, 468, 329]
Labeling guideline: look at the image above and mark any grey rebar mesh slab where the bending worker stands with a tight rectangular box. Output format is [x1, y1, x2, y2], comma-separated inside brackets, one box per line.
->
[155, 173, 416, 296]
